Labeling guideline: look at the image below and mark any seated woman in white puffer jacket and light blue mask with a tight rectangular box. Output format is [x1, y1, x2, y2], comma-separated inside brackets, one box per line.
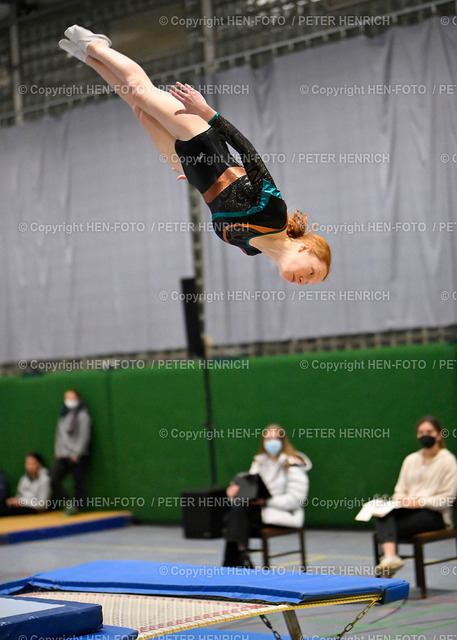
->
[224, 424, 312, 567]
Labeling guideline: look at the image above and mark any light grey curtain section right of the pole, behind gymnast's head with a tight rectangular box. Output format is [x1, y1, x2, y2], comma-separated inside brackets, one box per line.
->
[205, 19, 457, 344]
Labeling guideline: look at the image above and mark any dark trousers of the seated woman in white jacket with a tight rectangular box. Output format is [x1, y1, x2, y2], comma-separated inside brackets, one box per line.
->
[223, 498, 262, 567]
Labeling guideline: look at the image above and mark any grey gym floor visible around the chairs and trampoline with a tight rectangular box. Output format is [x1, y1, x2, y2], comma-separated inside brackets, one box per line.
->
[0, 525, 457, 640]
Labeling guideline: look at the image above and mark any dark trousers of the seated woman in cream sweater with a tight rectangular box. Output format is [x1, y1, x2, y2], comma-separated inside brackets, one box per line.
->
[375, 509, 444, 543]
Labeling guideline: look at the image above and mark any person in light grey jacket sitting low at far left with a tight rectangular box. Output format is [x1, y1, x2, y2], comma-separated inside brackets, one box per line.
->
[0, 452, 51, 516]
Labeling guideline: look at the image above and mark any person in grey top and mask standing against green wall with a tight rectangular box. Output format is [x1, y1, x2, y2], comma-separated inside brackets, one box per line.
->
[51, 389, 91, 512]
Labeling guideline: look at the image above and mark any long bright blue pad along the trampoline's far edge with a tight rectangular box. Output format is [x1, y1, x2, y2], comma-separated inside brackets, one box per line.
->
[0, 560, 409, 605]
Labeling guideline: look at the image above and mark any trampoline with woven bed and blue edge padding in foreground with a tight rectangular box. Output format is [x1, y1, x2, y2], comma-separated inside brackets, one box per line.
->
[0, 560, 409, 640]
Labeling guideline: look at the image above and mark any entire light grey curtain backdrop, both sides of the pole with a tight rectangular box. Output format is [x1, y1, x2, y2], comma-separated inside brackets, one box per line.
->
[0, 20, 457, 362]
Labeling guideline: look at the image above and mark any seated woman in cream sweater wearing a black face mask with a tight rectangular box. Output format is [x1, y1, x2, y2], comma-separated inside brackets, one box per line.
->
[375, 416, 457, 576]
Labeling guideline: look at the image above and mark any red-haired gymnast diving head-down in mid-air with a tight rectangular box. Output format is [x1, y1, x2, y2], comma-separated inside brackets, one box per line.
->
[59, 25, 331, 285]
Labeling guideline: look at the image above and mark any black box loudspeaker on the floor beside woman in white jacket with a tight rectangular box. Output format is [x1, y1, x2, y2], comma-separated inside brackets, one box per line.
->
[181, 487, 230, 538]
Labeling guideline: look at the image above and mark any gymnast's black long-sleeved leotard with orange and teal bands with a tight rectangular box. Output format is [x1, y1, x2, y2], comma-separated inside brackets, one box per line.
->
[175, 114, 287, 255]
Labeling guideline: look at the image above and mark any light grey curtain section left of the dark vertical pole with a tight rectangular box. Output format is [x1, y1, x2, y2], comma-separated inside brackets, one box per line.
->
[0, 100, 193, 362]
